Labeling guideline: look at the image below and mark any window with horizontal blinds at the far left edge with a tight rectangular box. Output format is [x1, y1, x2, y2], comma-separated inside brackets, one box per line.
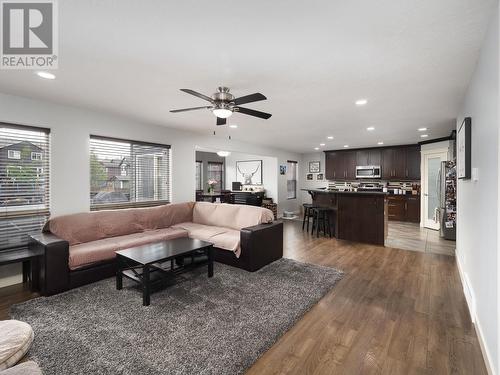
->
[0, 123, 50, 250]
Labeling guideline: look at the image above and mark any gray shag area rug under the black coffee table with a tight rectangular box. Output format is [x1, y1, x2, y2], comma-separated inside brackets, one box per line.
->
[11, 259, 342, 375]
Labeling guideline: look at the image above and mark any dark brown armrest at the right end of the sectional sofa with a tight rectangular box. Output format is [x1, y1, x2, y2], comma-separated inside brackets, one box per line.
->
[240, 221, 283, 271]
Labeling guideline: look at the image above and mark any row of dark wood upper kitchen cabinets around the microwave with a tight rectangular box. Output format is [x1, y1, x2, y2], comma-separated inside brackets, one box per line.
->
[325, 145, 420, 181]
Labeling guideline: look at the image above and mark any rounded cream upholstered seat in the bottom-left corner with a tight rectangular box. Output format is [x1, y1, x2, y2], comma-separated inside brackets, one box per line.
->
[0, 320, 33, 371]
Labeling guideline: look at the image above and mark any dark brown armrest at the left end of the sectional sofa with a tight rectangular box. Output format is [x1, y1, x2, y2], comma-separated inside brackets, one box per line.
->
[29, 233, 69, 296]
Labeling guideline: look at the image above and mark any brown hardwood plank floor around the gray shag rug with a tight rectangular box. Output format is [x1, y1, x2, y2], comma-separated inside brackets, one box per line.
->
[0, 221, 486, 375]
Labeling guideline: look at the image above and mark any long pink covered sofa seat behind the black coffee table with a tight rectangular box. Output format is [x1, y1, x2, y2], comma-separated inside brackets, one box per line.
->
[69, 228, 188, 270]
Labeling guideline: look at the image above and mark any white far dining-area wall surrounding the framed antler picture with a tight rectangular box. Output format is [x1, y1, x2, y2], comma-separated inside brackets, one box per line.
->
[226, 152, 279, 202]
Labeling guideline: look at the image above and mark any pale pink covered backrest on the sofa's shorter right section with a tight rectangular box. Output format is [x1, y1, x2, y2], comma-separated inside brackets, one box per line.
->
[193, 202, 274, 230]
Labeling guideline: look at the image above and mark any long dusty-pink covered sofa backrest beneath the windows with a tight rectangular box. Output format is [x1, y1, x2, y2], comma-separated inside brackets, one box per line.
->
[44, 202, 194, 245]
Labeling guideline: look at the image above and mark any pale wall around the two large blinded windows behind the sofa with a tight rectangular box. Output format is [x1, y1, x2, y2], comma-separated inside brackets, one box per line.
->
[0, 94, 300, 286]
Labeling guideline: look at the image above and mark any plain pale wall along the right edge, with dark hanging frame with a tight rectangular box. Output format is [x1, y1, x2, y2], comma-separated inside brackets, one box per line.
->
[457, 11, 499, 374]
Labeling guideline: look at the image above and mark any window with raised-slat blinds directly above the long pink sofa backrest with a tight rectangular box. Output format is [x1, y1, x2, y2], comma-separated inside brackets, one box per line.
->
[90, 135, 170, 210]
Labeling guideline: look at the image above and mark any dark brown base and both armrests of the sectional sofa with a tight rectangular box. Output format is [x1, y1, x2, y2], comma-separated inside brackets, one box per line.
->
[30, 221, 283, 296]
